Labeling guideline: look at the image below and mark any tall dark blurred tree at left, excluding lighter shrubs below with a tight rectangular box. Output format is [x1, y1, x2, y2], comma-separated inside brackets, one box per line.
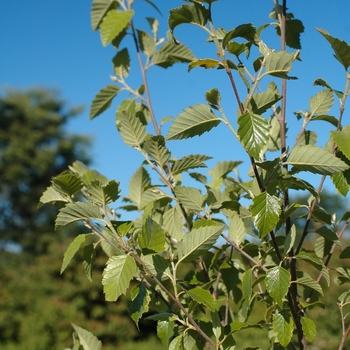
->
[0, 89, 90, 252]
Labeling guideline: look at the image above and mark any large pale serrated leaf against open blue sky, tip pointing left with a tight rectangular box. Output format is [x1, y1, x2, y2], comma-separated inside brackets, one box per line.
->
[166, 104, 221, 140]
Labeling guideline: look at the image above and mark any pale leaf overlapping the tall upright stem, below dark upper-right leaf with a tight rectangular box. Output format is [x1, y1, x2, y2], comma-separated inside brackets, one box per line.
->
[265, 51, 295, 79]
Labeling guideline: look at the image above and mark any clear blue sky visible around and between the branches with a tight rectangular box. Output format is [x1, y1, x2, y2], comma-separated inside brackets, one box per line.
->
[0, 0, 350, 200]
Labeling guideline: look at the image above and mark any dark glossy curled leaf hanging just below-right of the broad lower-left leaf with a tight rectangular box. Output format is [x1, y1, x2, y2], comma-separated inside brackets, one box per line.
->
[128, 283, 151, 329]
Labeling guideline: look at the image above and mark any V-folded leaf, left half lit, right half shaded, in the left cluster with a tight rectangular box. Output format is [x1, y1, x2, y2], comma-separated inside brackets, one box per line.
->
[87, 180, 120, 206]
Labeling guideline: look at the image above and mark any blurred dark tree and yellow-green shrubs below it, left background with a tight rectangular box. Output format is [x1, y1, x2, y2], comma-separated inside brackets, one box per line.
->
[0, 89, 160, 350]
